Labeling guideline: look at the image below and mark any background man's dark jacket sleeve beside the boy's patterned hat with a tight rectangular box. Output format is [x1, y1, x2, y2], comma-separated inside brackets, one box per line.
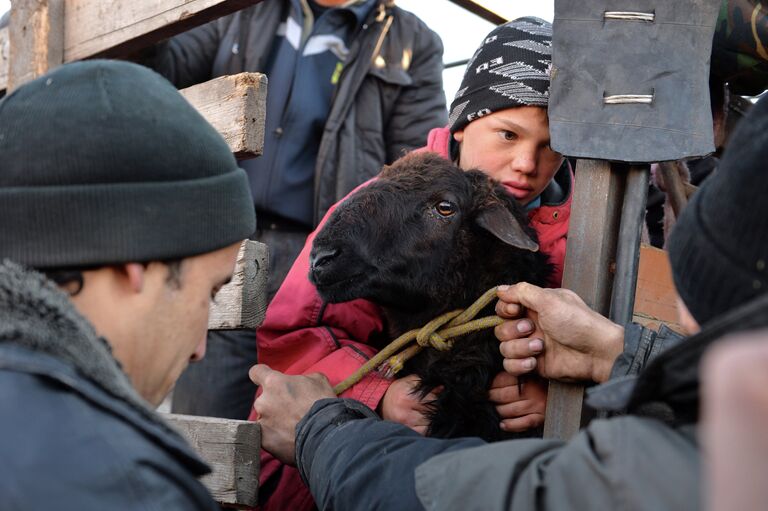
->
[384, 21, 448, 163]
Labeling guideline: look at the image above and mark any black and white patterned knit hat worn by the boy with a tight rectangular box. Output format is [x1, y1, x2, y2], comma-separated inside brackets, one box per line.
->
[448, 17, 552, 133]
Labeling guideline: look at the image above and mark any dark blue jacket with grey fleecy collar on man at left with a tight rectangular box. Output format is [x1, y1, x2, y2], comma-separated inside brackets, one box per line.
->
[0, 261, 217, 510]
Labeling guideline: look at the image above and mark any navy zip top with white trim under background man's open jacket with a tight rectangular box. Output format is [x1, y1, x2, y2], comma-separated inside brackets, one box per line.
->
[243, 0, 374, 227]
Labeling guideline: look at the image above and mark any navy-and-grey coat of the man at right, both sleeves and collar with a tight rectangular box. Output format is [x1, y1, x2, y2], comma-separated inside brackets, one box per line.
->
[296, 295, 768, 511]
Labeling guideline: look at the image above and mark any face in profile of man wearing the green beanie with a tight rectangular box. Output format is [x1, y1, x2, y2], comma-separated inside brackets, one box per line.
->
[130, 243, 240, 405]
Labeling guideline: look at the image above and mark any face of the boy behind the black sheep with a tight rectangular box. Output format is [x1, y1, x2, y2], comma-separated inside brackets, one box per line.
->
[453, 106, 563, 205]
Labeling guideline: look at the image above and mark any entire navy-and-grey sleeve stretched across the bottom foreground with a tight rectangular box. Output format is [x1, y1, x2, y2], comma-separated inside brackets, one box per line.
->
[296, 399, 700, 511]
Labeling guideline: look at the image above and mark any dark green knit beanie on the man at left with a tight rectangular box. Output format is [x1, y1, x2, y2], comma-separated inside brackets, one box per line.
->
[0, 60, 255, 269]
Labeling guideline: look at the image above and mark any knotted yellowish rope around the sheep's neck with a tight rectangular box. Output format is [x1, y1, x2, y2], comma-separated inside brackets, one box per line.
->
[333, 287, 504, 396]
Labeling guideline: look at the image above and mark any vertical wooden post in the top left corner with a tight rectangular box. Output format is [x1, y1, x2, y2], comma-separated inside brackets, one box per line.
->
[8, 0, 64, 90]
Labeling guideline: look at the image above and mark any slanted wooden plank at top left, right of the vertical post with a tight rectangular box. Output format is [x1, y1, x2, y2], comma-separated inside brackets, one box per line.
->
[64, 0, 260, 62]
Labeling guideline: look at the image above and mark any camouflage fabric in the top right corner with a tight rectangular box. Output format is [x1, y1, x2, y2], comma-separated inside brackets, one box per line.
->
[711, 0, 768, 96]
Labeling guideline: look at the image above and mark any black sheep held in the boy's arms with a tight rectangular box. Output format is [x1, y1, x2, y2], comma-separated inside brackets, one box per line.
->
[309, 153, 550, 441]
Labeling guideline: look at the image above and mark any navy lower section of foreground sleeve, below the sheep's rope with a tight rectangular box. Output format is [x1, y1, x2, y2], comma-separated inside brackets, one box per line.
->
[296, 399, 483, 511]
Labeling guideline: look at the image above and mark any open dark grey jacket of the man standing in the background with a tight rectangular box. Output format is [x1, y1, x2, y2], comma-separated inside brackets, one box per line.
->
[150, 0, 448, 225]
